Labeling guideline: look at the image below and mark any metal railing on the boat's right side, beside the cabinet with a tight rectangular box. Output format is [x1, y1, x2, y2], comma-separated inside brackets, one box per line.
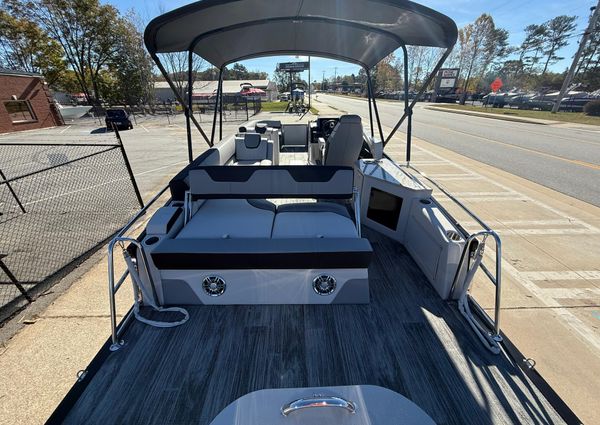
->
[407, 165, 502, 353]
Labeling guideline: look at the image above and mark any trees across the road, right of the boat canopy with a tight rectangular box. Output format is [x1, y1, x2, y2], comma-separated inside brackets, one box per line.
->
[328, 13, 600, 94]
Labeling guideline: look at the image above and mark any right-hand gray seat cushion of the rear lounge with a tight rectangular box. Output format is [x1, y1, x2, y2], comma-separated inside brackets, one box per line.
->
[271, 212, 358, 238]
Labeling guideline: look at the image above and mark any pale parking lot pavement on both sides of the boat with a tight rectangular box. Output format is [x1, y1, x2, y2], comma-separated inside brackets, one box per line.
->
[0, 104, 600, 423]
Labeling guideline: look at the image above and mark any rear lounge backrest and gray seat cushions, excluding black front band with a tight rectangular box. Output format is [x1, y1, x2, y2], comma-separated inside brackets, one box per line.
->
[177, 166, 358, 239]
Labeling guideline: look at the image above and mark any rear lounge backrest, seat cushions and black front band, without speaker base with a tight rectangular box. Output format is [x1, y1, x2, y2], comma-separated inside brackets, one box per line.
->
[152, 166, 372, 269]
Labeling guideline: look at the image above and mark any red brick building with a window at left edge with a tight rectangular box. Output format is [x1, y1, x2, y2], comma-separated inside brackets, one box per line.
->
[0, 68, 63, 133]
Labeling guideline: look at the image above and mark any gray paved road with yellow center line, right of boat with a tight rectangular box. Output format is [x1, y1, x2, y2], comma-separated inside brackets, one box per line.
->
[318, 94, 600, 206]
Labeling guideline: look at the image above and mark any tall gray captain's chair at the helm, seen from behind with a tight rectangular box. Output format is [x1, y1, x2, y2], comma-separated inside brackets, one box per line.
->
[323, 115, 363, 167]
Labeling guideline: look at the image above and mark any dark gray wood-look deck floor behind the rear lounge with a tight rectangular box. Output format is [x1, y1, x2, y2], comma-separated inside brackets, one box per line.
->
[66, 232, 562, 424]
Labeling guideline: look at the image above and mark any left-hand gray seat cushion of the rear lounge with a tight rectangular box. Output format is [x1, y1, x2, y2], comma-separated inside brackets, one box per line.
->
[177, 199, 275, 239]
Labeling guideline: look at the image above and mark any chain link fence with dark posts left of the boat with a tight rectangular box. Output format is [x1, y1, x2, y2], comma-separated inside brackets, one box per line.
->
[0, 138, 142, 323]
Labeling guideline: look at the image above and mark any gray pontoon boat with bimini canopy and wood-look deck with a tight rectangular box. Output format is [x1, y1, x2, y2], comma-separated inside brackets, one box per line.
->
[49, 0, 577, 425]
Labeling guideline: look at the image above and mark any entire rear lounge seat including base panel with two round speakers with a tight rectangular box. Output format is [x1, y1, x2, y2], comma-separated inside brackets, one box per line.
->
[142, 166, 372, 305]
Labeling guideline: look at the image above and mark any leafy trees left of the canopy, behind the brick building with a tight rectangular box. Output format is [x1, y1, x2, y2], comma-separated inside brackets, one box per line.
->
[0, 0, 268, 106]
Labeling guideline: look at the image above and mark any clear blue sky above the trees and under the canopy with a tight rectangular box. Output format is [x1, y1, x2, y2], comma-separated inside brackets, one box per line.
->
[108, 0, 596, 81]
